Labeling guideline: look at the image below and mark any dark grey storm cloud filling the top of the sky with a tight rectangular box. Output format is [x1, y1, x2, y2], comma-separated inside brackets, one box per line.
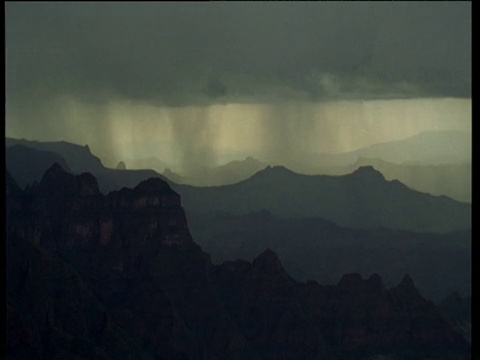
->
[6, 2, 471, 106]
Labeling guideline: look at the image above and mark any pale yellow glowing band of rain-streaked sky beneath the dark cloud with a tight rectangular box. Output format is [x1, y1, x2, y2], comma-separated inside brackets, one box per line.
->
[6, 96, 472, 168]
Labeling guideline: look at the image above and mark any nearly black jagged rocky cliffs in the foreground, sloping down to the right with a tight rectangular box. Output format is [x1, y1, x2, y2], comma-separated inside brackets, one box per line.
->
[6, 165, 470, 359]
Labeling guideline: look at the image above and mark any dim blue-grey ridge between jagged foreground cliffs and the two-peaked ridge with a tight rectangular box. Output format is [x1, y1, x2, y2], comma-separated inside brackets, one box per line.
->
[188, 211, 472, 302]
